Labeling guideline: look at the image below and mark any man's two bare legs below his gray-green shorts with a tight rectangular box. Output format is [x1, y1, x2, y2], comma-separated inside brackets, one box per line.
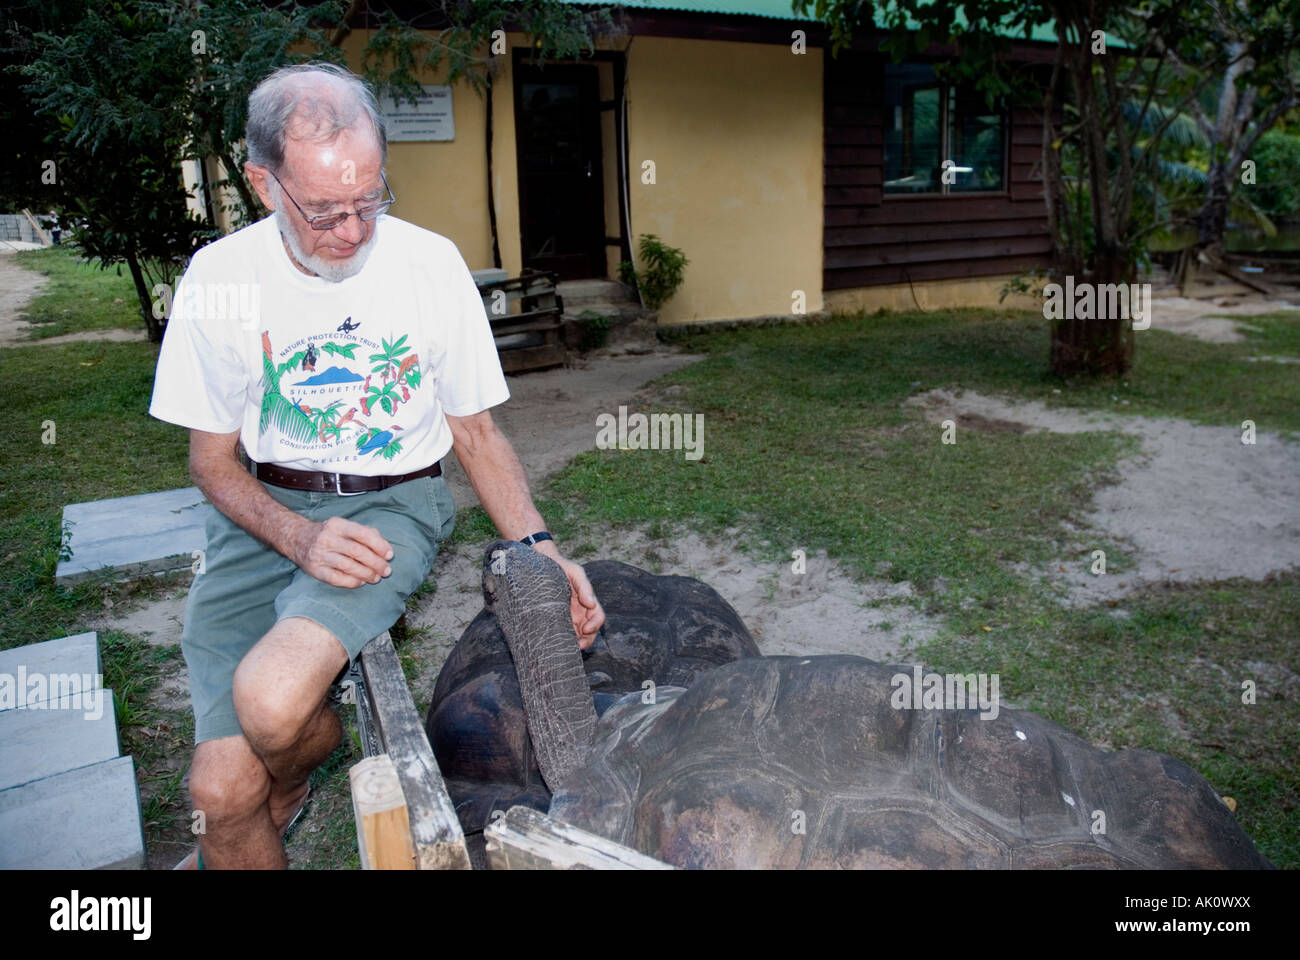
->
[190, 617, 347, 869]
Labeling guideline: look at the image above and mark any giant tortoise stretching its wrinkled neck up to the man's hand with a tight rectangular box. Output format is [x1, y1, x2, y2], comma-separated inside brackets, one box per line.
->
[438, 541, 1269, 868]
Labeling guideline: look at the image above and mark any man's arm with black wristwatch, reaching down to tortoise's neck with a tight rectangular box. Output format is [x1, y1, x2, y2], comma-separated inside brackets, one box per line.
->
[447, 410, 605, 650]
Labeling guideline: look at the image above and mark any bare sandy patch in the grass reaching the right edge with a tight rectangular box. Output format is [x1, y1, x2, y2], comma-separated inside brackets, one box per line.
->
[907, 390, 1300, 604]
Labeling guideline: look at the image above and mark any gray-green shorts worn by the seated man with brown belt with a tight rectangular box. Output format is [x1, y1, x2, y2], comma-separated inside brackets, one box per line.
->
[181, 476, 456, 743]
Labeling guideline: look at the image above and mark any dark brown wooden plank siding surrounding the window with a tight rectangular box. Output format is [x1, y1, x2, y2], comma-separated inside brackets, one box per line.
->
[822, 51, 1050, 290]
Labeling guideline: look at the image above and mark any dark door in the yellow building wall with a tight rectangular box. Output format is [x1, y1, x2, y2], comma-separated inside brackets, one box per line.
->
[515, 64, 606, 280]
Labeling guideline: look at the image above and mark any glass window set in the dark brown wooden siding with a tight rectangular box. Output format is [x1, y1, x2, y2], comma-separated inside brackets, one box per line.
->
[884, 64, 1006, 195]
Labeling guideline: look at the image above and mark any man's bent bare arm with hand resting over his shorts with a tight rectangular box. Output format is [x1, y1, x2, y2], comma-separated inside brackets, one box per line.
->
[190, 429, 393, 587]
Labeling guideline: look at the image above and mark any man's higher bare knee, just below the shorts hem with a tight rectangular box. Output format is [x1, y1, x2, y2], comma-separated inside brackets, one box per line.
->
[231, 618, 347, 754]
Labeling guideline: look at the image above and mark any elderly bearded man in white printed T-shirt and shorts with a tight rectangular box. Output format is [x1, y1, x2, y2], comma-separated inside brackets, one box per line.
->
[150, 65, 605, 868]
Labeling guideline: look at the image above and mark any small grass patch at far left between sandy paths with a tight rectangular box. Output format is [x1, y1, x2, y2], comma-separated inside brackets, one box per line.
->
[14, 246, 144, 340]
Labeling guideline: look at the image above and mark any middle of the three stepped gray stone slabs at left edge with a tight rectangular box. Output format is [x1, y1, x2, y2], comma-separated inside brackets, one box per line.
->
[0, 688, 118, 790]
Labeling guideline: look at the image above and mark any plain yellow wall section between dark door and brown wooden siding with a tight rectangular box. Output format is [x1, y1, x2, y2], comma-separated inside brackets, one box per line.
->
[628, 36, 823, 324]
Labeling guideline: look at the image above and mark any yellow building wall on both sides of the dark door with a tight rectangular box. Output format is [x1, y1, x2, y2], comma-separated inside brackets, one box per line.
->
[343, 30, 822, 324]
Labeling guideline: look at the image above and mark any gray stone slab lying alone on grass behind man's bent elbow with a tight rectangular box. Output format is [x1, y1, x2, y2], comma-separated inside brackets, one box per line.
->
[55, 487, 212, 583]
